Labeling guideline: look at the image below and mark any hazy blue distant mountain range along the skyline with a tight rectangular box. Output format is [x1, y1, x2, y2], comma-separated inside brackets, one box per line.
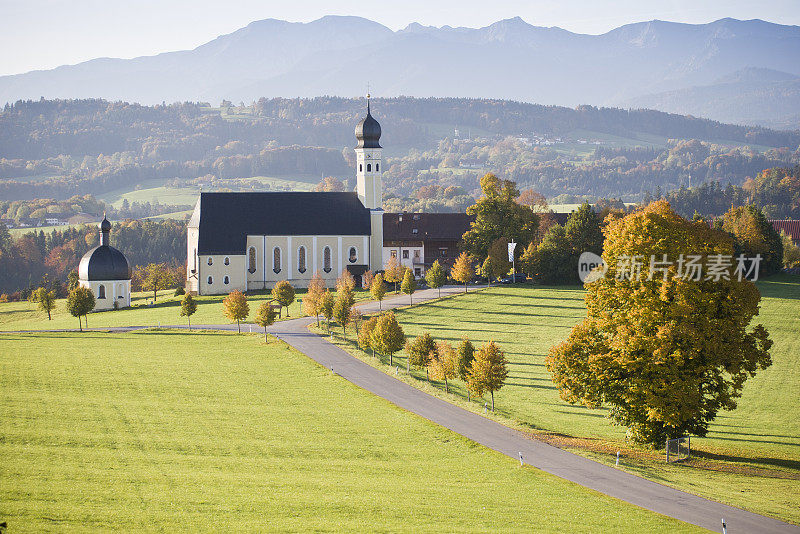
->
[0, 16, 800, 129]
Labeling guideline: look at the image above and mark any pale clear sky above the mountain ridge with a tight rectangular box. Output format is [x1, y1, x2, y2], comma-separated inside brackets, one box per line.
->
[0, 0, 800, 75]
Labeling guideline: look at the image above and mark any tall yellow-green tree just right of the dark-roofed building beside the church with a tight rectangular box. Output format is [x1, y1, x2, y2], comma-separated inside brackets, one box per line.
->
[463, 173, 538, 258]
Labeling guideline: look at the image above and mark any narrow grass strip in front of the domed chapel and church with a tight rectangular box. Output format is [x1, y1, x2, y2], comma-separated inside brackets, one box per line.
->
[0, 289, 371, 331]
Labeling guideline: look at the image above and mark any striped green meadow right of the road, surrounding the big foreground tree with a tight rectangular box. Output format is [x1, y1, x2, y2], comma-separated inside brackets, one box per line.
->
[322, 277, 800, 523]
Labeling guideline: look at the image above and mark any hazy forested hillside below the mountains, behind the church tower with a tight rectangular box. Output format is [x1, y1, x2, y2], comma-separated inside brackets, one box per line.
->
[0, 97, 800, 204]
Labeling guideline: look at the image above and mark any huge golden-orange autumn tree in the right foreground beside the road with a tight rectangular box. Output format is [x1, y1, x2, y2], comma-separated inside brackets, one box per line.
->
[546, 201, 772, 445]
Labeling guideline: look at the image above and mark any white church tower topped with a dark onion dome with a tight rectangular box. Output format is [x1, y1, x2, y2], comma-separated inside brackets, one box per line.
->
[355, 95, 383, 271]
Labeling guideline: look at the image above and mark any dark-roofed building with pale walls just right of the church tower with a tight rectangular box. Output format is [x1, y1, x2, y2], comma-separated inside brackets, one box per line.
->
[383, 213, 473, 278]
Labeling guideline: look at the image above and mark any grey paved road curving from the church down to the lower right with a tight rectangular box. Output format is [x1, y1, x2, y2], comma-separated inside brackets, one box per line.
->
[7, 287, 800, 534]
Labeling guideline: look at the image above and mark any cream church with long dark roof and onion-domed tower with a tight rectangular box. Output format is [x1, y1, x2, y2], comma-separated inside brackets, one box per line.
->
[186, 99, 384, 295]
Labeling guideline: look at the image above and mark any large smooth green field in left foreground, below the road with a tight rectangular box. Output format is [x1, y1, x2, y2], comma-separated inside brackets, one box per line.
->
[0, 331, 700, 532]
